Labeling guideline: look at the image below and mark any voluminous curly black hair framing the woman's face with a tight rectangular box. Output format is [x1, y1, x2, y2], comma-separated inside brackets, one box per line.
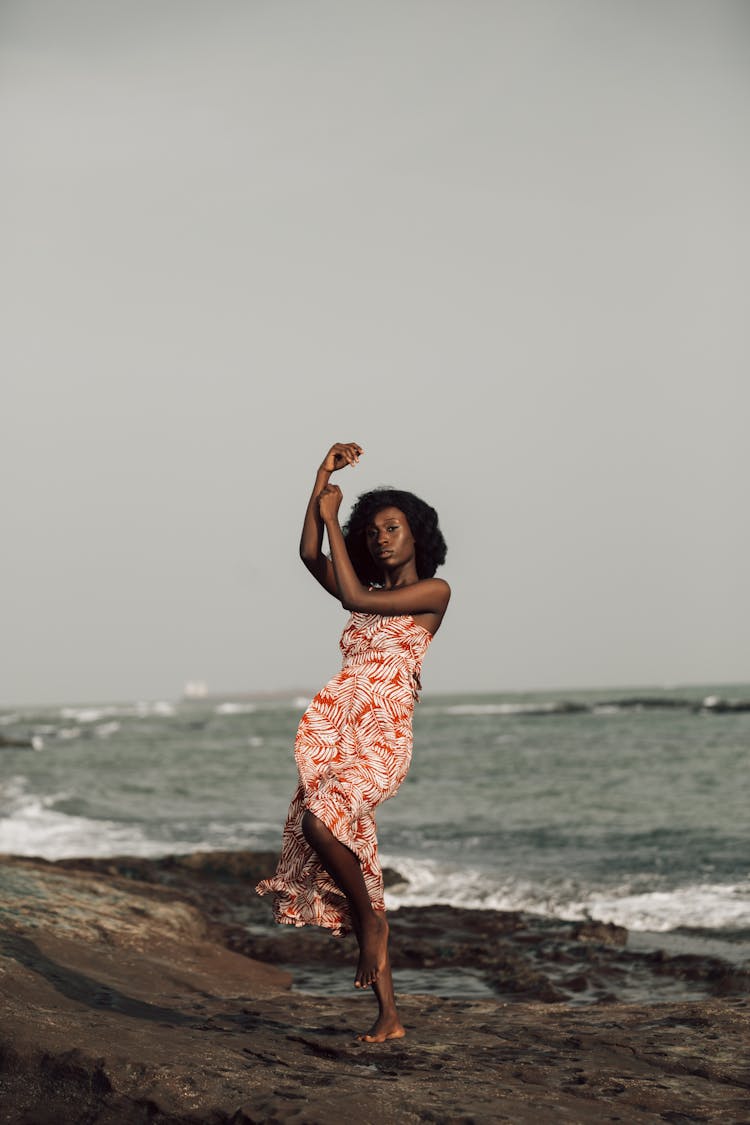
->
[343, 487, 448, 584]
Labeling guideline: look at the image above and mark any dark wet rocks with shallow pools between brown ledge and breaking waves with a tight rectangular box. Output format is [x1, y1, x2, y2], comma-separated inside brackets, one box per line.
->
[8, 851, 750, 1008]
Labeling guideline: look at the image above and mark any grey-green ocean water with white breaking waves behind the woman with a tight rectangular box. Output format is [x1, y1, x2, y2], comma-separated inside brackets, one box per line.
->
[0, 685, 750, 946]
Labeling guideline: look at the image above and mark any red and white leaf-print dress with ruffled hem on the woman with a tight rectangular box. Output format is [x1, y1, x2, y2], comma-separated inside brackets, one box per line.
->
[256, 613, 432, 935]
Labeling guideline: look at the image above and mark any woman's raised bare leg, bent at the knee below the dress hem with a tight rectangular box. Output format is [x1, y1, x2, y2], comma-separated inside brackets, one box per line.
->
[301, 810, 388, 988]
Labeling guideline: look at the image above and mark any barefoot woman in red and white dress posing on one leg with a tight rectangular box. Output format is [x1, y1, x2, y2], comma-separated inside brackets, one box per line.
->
[257, 442, 451, 1043]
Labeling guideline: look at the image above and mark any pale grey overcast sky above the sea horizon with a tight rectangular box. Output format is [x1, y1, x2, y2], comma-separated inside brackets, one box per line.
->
[0, 0, 750, 705]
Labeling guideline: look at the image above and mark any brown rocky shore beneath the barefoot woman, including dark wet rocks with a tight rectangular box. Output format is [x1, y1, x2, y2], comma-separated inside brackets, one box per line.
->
[0, 853, 750, 1125]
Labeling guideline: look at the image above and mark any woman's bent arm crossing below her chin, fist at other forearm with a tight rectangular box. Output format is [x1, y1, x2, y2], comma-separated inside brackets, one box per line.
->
[320, 485, 451, 618]
